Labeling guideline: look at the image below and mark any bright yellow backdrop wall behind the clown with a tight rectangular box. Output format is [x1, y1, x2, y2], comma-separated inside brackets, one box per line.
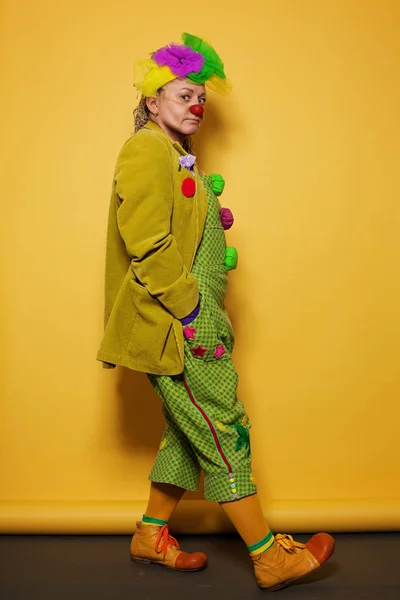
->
[0, 0, 400, 532]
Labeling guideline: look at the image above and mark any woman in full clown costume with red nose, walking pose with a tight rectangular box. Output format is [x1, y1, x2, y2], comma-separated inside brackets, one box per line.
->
[97, 33, 334, 590]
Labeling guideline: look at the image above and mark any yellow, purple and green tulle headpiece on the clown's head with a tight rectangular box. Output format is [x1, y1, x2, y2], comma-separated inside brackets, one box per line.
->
[134, 33, 232, 96]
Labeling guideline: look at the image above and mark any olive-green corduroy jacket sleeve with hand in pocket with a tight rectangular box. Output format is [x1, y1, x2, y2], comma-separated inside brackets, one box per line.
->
[115, 131, 199, 319]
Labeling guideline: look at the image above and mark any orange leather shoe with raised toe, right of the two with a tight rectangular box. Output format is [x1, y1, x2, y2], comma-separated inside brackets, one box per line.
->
[251, 533, 335, 592]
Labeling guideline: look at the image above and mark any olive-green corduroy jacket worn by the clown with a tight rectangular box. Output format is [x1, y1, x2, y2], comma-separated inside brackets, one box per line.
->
[97, 121, 207, 375]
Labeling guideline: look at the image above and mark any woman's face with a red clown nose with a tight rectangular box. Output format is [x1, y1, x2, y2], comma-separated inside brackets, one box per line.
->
[146, 78, 206, 143]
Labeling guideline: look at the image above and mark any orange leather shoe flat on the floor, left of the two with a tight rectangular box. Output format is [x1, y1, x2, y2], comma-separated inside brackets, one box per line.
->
[130, 521, 207, 571]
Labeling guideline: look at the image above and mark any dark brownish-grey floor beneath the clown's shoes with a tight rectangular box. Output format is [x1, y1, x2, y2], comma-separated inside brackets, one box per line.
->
[0, 533, 400, 600]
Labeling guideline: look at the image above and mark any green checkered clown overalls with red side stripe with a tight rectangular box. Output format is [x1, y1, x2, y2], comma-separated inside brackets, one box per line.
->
[149, 176, 257, 502]
